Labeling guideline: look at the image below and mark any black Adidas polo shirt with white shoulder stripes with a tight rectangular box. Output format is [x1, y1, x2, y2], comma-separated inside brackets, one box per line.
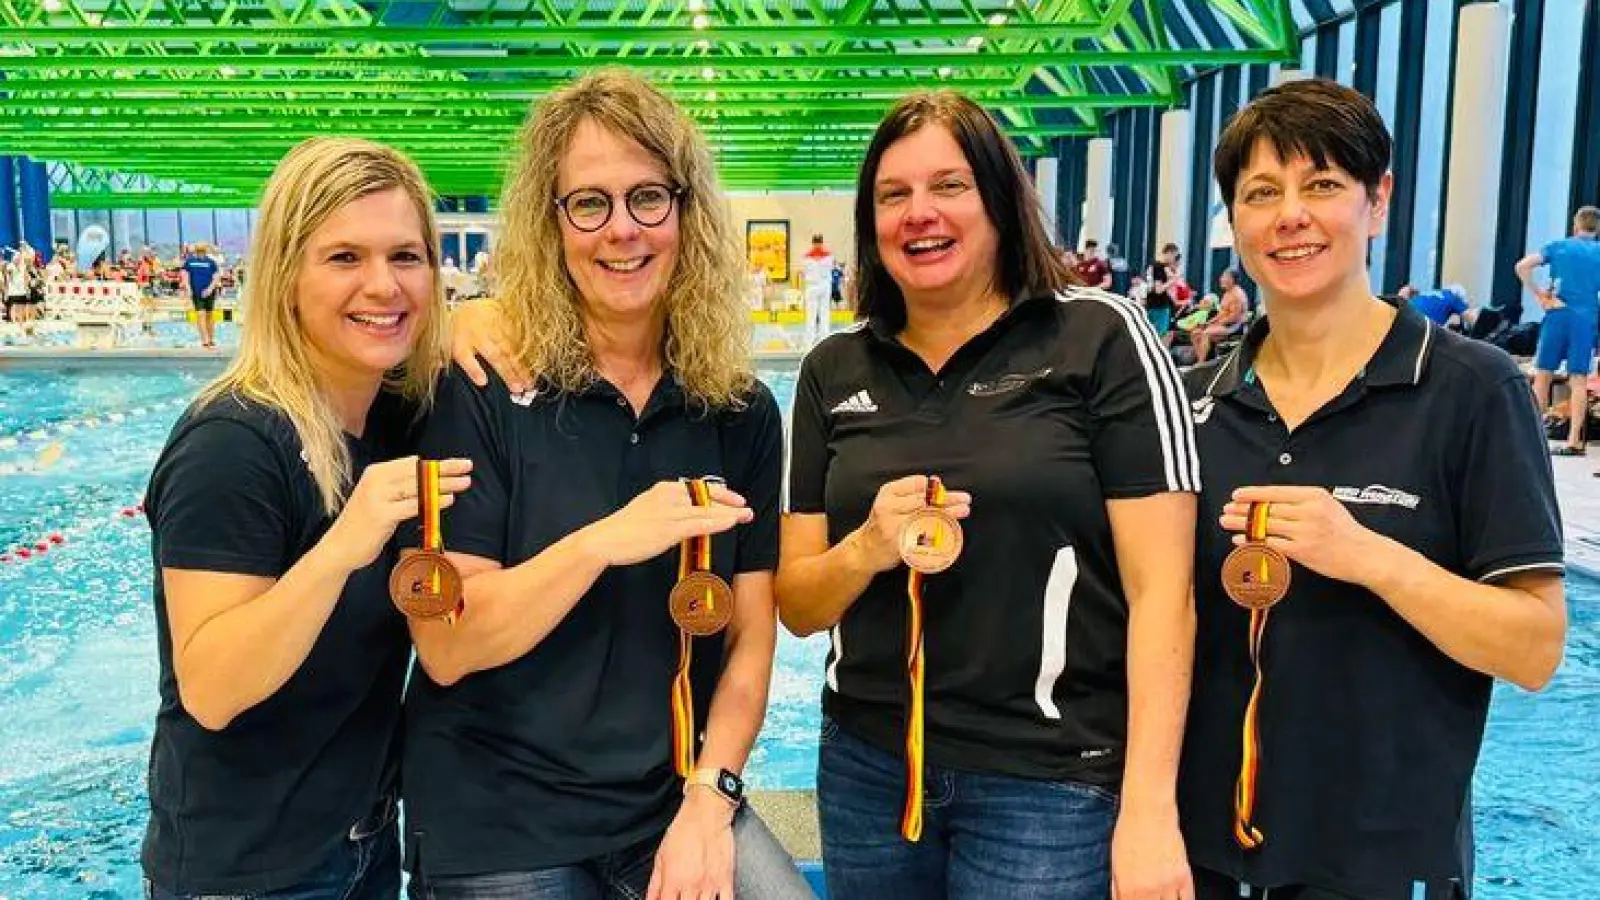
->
[790, 288, 1198, 785]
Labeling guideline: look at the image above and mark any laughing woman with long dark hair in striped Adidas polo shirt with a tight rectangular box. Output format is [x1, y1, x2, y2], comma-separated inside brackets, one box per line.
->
[778, 91, 1198, 900]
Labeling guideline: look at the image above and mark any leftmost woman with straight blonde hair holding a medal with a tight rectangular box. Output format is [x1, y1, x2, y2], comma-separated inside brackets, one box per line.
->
[142, 138, 470, 898]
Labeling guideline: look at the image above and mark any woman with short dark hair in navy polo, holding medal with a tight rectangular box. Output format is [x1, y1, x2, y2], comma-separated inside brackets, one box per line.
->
[1179, 80, 1566, 900]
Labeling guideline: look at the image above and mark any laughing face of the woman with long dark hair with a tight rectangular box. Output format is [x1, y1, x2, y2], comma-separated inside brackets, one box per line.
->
[874, 123, 1000, 312]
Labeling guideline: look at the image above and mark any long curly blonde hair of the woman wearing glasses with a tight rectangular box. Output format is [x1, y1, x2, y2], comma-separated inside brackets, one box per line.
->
[494, 69, 755, 408]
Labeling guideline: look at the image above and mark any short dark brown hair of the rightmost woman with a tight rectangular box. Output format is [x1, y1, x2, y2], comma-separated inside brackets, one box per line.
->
[1211, 78, 1394, 215]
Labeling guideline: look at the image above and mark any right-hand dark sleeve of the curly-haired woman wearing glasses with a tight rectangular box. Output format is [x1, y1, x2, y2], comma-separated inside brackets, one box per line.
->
[731, 381, 784, 573]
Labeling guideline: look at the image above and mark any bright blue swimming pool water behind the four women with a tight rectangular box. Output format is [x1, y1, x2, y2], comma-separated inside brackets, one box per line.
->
[0, 364, 1600, 900]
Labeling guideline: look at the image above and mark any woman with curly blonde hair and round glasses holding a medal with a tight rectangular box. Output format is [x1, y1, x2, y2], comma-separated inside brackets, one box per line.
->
[403, 70, 810, 900]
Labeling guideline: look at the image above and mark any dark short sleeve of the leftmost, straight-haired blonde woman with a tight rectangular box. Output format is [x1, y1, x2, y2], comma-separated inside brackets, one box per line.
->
[147, 418, 294, 577]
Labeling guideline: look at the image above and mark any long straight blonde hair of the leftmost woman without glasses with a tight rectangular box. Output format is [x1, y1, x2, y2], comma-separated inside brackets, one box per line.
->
[198, 138, 448, 516]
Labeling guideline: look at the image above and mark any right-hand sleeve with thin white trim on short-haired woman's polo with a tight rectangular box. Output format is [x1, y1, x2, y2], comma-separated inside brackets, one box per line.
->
[1456, 360, 1563, 581]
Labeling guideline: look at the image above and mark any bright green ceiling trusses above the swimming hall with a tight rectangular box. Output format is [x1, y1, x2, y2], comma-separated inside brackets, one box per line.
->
[0, 0, 1296, 208]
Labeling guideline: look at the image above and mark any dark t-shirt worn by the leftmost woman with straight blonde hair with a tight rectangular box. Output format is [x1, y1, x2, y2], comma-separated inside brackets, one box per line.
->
[144, 387, 416, 894]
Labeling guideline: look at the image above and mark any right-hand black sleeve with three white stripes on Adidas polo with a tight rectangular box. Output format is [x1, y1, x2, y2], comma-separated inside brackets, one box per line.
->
[1088, 299, 1200, 500]
